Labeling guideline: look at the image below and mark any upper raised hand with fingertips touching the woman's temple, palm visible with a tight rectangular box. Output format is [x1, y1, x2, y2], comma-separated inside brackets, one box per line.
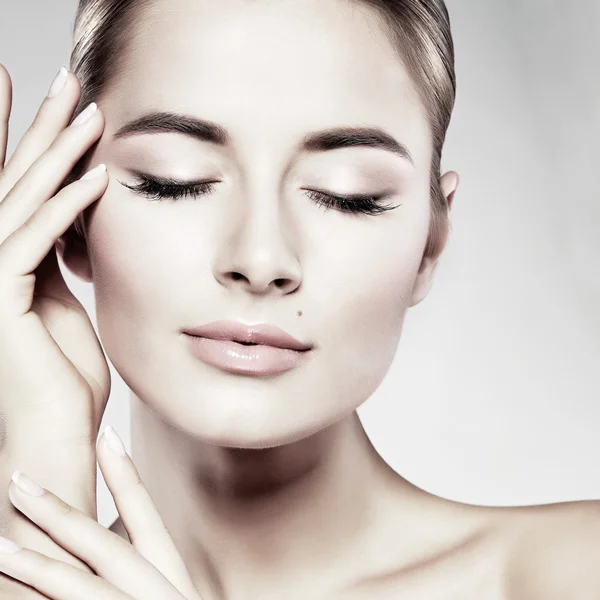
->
[0, 65, 110, 556]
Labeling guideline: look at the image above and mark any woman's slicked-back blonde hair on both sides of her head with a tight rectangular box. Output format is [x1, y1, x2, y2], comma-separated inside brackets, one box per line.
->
[71, 0, 456, 257]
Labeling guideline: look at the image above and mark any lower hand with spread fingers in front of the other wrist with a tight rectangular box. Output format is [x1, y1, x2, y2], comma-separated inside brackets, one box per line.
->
[0, 431, 201, 600]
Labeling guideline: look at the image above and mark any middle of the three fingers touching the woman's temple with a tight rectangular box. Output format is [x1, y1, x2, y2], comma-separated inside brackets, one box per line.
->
[0, 103, 104, 244]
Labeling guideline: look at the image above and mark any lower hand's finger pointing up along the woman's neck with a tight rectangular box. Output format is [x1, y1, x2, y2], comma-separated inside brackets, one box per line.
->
[96, 426, 197, 598]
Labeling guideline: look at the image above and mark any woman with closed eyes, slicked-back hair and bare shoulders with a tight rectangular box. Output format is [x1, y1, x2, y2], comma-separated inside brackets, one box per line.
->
[0, 0, 600, 600]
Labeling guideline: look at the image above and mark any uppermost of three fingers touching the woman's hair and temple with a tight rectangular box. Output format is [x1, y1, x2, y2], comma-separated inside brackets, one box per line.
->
[0, 67, 81, 201]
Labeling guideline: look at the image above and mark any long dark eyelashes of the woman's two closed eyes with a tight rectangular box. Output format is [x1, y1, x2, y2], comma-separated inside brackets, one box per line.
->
[120, 175, 400, 215]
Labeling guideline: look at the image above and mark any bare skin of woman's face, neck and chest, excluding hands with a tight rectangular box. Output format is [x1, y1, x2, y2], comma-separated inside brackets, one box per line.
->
[52, 0, 600, 600]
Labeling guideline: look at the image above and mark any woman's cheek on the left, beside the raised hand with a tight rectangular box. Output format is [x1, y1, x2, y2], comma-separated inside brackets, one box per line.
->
[88, 198, 206, 380]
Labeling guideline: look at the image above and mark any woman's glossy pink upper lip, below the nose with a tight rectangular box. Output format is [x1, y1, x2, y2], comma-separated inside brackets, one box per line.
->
[183, 321, 314, 352]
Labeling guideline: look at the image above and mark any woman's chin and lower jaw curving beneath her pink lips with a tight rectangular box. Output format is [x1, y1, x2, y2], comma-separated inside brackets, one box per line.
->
[125, 332, 390, 449]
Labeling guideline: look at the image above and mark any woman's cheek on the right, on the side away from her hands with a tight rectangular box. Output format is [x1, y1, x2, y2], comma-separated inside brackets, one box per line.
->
[311, 201, 428, 399]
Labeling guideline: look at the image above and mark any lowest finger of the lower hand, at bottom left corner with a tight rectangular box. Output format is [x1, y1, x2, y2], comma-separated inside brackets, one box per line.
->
[0, 548, 135, 600]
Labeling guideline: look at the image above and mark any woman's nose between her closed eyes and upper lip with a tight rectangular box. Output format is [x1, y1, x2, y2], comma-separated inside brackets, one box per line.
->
[214, 191, 302, 295]
